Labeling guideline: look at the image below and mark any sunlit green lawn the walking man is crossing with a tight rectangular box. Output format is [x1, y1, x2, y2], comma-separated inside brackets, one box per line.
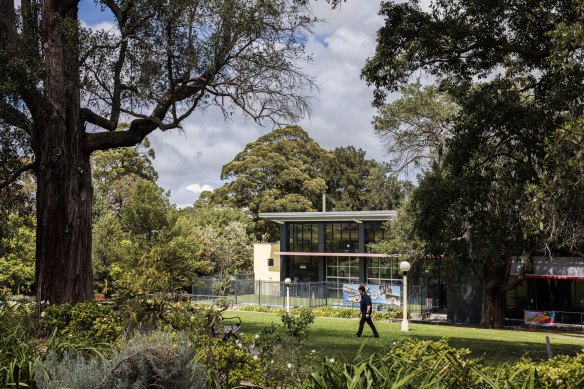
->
[233, 311, 584, 365]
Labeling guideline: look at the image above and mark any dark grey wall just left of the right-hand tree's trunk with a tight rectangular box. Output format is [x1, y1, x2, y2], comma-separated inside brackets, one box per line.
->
[447, 265, 483, 324]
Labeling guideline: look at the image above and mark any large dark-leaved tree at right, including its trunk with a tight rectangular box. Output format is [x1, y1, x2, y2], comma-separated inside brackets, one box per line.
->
[362, 0, 584, 327]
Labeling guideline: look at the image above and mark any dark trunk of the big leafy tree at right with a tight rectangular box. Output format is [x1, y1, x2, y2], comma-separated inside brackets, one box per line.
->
[481, 255, 511, 328]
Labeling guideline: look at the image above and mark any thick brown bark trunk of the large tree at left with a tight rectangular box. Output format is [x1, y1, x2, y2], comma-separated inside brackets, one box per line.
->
[34, 0, 93, 304]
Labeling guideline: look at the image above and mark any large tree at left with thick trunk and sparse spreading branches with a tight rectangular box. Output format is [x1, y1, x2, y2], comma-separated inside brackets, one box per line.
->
[0, 0, 314, 303]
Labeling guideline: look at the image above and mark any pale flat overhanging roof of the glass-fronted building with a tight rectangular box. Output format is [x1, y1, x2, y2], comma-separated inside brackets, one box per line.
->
[258, 211, 397, 224]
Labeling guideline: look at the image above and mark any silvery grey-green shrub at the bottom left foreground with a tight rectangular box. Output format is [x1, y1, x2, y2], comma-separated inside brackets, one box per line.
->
[35, 333, 206, 389]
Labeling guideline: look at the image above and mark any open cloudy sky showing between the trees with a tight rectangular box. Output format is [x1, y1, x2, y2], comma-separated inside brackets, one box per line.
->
[79, 0, 386, 207]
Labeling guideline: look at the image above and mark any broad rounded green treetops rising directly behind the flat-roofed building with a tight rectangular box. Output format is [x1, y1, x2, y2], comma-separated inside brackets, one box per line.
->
[210, 126, 402, 239]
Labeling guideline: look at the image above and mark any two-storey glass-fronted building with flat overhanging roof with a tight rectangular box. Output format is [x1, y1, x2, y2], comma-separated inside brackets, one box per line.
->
[257, 211, 401, 298]
